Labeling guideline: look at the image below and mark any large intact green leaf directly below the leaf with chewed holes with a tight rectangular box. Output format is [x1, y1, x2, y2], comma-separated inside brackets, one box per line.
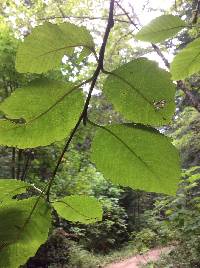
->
[91, 124, 181, 194]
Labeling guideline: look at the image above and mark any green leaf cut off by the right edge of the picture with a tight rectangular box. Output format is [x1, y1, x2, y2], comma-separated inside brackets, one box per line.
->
[170, 38, 200, 80]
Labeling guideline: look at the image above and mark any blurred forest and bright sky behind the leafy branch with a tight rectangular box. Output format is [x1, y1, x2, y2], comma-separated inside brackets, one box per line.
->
[0, 0, 200, 268]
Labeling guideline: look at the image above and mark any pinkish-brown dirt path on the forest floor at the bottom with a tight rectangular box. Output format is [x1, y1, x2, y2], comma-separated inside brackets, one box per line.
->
[105, 247, 171, 268]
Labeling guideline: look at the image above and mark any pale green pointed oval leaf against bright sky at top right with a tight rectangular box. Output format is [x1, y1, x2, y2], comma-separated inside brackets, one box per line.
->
[135, 15, 186, 43]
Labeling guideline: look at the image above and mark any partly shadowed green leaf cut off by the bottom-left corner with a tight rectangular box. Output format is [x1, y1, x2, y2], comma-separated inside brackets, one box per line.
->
[0, 198, 51, 268]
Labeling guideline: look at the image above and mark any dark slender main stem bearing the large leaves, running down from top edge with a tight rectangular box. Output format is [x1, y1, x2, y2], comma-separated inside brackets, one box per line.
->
[46, 0, 115, 201]
